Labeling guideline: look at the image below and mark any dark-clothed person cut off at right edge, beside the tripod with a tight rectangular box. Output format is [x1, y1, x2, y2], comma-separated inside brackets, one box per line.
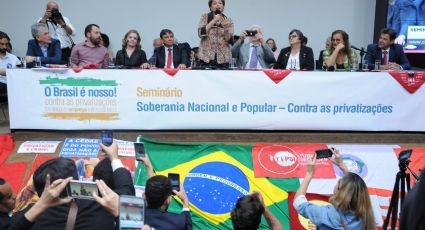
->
[400, 169, 425, 230]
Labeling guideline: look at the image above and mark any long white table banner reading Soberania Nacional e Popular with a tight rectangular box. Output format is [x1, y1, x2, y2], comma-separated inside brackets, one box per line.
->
[7, 69, 425, 131]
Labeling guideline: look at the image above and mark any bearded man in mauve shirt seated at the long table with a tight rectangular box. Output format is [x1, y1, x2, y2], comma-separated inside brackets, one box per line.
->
[71, 24, 109, 68]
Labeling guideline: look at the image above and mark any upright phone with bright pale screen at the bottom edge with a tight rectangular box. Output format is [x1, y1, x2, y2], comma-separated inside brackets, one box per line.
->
[119, 195, 145, 229]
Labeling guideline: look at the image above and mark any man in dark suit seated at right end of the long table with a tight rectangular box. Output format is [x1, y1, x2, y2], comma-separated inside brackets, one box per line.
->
[365, 28, 410, 70]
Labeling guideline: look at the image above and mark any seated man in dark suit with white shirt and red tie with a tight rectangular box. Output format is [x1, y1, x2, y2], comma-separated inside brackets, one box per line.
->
[153, 29, 190, 69]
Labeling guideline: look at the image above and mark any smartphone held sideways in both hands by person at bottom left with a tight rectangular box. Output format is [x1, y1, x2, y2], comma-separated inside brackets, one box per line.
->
[67, 180, 100, 200]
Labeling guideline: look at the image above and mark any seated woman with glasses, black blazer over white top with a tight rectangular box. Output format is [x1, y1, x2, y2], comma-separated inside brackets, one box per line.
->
[274, 29, 314, 70]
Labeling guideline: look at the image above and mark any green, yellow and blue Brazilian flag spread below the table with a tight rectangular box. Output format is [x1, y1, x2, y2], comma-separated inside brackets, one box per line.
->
[135, 136, 299, 229]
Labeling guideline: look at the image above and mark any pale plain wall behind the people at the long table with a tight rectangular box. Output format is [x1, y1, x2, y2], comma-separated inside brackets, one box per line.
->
[0, 0, 375, 59]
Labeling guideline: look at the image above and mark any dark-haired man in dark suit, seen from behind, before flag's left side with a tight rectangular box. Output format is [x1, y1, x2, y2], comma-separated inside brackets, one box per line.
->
[145, 175, 192, 230]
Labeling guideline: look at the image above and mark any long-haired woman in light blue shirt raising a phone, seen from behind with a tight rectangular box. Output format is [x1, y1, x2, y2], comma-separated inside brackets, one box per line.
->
[293, 148, 375, 230]
